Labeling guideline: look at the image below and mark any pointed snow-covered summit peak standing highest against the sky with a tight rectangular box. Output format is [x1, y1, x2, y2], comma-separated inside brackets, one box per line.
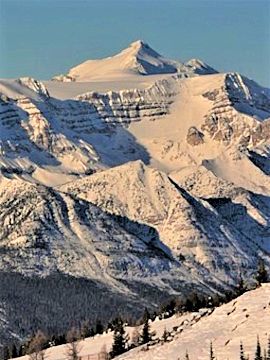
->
[53, 40, 225, 82]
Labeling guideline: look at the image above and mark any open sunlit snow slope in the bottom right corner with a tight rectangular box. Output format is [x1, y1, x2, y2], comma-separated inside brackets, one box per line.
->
[117, 284, 270, 360]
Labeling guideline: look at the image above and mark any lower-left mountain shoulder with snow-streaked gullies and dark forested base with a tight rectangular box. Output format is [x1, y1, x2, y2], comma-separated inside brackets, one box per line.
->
[0, 177, 205, 344]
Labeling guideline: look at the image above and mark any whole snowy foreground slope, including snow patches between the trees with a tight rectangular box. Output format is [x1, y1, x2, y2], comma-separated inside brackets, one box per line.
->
[13, 284, 270, 360]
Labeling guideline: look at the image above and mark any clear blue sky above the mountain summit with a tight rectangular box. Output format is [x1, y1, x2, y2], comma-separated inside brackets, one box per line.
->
[0, 0, 270, 86]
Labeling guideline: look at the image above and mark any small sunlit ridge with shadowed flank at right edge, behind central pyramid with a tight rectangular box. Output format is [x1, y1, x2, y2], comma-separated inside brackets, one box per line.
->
[171, 165, 270, 253]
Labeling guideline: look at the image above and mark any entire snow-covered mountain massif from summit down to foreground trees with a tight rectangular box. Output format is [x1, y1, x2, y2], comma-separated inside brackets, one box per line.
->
[0, 42, 270, 344]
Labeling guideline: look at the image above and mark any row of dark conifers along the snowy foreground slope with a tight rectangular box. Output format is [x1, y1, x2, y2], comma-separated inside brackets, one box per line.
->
[1, 260, 270, 360]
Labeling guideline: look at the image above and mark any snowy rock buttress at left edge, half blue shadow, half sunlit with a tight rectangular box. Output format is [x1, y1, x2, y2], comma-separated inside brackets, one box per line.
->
[0, 90, 102, 177]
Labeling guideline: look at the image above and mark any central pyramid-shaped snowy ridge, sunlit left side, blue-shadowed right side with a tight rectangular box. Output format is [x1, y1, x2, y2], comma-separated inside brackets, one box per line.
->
[61, 161, 256, 282]
